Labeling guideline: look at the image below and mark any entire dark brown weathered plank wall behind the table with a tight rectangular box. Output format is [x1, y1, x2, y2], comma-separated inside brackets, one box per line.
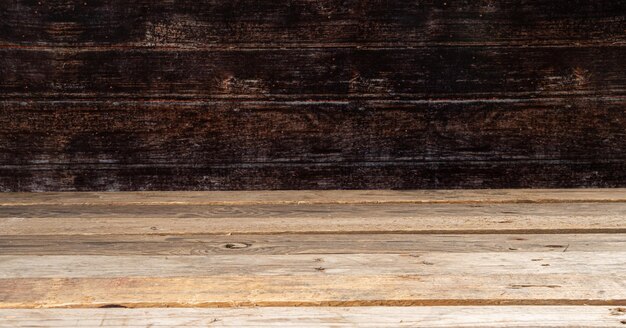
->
[0, 0, 626, 191]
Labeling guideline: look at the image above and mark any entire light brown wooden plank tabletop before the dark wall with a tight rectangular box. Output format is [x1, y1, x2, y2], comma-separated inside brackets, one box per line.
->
[0, 189, 626, 327]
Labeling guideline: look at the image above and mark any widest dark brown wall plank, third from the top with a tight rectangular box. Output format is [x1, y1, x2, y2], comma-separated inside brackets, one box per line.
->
[0, 98, 626, 167]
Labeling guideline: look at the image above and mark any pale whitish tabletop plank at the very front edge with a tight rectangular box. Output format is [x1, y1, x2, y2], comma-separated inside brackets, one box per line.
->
[0, 306, 626, 328]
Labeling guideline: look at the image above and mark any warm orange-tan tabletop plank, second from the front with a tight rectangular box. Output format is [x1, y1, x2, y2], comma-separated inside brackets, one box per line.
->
[0, 276, 626, 308]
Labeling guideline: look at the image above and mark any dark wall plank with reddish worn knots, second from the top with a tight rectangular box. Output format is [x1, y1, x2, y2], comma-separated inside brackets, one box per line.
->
[0, 46, 626, 100]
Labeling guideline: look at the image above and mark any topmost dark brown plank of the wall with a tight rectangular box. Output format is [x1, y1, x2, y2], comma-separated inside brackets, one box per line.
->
[0, 0, 626, 47]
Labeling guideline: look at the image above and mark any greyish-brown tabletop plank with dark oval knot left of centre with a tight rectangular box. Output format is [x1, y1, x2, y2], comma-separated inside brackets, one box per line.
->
[0, 233, 626, 256]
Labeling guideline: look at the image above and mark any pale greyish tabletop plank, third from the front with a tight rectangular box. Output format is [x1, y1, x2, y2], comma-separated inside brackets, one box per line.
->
[0, 251, 626, 278]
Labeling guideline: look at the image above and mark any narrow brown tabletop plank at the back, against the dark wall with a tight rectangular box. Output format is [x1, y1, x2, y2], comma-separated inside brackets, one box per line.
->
[0, 188, 626, 206]
